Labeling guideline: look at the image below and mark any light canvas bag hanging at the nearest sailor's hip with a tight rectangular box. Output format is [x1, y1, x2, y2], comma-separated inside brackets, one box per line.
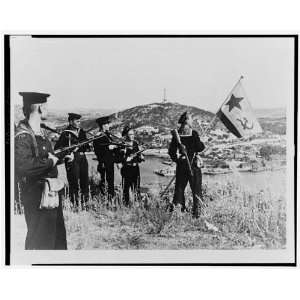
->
[40, 178, 65, 209]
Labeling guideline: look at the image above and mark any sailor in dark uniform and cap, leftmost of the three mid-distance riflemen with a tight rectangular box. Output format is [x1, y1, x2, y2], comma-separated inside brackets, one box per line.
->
[54, 113, 90, 207]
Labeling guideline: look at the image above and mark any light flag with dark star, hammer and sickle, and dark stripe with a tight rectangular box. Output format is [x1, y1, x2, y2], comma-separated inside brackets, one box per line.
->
[217, 81, 262, 138]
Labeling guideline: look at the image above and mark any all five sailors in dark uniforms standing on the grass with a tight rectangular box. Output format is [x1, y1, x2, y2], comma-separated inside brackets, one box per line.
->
[15, 92, 204, 249]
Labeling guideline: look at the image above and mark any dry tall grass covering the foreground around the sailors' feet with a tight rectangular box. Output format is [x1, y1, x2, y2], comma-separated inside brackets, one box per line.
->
[13, 175, 286, 249]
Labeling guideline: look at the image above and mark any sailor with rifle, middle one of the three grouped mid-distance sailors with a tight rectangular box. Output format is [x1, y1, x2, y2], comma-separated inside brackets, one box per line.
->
[93, 116, 117, 200]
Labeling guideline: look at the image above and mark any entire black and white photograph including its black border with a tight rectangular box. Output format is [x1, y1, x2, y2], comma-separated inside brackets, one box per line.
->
[4, 34, 298, 265]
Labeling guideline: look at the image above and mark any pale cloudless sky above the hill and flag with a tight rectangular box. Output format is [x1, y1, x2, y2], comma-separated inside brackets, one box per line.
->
[10, 36, 294, 112]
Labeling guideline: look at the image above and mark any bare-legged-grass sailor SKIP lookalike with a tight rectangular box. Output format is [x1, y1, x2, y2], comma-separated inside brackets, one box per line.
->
[121, 126, 144, 206]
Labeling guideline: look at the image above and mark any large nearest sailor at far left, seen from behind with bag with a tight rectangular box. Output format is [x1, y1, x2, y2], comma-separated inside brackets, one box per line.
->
[15, 92, 67, 250]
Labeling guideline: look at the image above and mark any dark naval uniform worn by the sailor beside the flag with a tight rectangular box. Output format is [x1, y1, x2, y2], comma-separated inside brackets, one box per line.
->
[169, 130, 205, 217]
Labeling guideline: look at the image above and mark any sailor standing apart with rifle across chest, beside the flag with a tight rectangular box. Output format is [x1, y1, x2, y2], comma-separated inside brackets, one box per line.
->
[169, 112, 205, 218]
